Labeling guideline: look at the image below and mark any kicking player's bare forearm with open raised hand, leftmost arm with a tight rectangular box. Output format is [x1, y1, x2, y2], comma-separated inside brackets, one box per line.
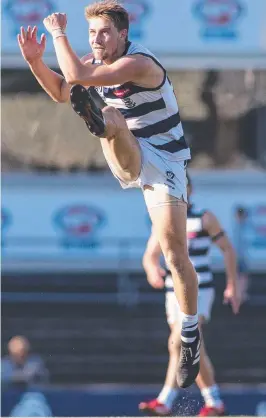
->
[17, 26, 70, 103]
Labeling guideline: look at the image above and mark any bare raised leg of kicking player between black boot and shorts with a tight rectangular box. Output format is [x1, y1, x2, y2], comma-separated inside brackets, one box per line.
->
[101, 106, 141, 183]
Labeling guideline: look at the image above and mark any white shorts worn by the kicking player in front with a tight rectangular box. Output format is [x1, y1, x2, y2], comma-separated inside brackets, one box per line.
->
[108, 138, 187, 202]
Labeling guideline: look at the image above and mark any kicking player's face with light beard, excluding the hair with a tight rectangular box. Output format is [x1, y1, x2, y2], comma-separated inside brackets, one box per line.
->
[89, 17, 122, 61]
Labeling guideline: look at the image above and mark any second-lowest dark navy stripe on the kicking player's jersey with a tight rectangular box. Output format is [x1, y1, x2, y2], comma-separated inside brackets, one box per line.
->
[131, 112, 180, 139]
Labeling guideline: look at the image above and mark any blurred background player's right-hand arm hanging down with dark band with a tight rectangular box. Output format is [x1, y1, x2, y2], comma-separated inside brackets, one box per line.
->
[202, 212, 240, 313]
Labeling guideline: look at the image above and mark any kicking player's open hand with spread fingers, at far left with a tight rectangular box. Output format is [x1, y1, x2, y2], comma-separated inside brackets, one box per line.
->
[17, 26, 46, 64]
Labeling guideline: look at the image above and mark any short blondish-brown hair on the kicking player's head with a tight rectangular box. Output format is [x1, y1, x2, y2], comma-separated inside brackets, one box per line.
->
[85, 0, 129, 31]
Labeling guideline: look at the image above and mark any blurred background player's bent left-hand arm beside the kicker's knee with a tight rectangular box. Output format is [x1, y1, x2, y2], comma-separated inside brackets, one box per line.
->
[143, 230, 166, 289]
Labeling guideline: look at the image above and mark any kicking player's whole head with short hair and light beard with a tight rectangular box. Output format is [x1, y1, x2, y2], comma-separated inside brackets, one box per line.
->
[85, 0, 129, 63]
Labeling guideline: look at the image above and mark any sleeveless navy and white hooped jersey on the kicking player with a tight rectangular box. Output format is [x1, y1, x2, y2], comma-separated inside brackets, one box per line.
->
[93, 42, 190, 161]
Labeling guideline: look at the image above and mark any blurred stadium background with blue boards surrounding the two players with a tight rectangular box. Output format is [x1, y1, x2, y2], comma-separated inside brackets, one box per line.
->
[1, 0, 266, 416]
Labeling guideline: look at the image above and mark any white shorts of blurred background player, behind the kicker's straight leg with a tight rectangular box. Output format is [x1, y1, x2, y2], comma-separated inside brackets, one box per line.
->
[165, 288, 215, 325]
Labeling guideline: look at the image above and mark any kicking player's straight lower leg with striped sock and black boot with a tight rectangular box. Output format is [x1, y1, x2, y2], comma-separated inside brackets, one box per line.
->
[144, 187, 200, 388]
